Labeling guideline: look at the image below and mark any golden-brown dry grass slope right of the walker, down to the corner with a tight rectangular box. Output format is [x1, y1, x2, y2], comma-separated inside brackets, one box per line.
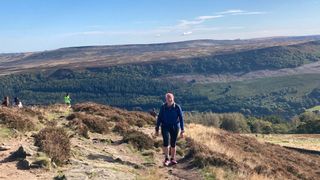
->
[187, 124, 320, 179]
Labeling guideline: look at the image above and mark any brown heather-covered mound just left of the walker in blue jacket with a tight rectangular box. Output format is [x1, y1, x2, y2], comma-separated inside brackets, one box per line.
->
[67, 103, 155, 137]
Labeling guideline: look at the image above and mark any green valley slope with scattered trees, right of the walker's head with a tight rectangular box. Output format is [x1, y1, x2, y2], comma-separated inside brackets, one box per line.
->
[184, 74, 320, 116]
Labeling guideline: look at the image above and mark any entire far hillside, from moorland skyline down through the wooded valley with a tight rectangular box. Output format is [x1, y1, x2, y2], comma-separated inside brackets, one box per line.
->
[0, 36, 320, 118]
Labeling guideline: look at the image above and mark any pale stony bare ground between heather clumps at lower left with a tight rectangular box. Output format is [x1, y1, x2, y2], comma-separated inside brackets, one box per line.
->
[0, 104, 201, 180]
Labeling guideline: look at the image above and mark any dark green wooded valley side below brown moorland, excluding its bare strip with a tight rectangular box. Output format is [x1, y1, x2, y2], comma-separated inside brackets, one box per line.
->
[0, 41, 320, 118]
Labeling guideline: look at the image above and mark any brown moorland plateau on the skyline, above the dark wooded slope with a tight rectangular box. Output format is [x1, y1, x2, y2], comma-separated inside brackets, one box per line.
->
[0, 36, 320, 74]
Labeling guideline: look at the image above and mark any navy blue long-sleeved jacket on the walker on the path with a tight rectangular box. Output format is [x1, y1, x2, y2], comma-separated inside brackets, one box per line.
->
[156, 103, 184, 131]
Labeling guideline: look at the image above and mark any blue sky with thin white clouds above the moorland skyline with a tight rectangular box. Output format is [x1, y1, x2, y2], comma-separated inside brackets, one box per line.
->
[0, 0, 320, 53]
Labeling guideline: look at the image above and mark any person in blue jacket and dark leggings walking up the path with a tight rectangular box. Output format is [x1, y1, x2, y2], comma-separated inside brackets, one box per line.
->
[156, 93, 184, 166]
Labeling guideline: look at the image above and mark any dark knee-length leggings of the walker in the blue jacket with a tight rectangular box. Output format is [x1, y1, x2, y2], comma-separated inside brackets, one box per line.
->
[161, 125, 179, 148]
